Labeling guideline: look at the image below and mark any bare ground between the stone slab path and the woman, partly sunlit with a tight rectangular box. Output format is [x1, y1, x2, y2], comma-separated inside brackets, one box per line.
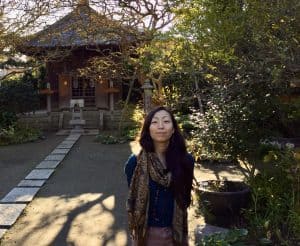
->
[1, 136, 131, 246]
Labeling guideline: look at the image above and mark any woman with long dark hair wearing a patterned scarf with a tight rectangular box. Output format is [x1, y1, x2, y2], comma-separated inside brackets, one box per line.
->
[125, 107, 194, 246]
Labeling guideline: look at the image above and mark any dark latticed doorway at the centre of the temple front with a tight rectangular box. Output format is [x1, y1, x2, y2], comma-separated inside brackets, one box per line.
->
[72, 76, 95, 107]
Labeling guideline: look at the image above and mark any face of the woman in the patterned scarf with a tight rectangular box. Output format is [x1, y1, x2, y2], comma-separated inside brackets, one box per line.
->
[149, 110, 174, 143]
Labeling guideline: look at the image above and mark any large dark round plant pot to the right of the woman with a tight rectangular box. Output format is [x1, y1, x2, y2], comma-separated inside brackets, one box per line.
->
[197, 180, 250, 227]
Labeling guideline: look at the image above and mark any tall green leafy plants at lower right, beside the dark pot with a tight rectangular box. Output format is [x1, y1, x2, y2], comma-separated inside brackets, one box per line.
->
[246, 147, 300, 245]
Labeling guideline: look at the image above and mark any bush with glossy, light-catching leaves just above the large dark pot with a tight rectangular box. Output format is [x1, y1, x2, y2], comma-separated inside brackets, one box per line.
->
[192, 72, 277, 161]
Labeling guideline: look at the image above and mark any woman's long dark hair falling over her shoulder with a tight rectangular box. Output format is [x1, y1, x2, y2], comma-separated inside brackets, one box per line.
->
[140, 107, 193, 208]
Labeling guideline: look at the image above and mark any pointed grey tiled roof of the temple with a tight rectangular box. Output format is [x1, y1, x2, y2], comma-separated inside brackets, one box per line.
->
[25, 5, 134, 48]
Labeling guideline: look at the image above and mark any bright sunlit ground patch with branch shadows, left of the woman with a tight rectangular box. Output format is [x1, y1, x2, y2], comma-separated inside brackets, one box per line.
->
[2, 193, 127, 246]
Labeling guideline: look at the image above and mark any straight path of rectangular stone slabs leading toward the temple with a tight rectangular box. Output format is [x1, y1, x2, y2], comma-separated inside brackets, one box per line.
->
[0, 134, 80, 241]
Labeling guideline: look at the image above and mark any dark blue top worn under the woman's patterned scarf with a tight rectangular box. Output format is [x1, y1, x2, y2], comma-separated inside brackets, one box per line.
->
[125, 154, 194, 227]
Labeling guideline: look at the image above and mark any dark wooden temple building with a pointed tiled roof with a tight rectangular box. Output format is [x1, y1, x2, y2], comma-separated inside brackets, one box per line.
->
[21, 0, 141, 131]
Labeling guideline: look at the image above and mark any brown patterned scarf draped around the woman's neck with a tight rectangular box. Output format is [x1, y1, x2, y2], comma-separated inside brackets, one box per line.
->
[127, 150, 188, 246]
